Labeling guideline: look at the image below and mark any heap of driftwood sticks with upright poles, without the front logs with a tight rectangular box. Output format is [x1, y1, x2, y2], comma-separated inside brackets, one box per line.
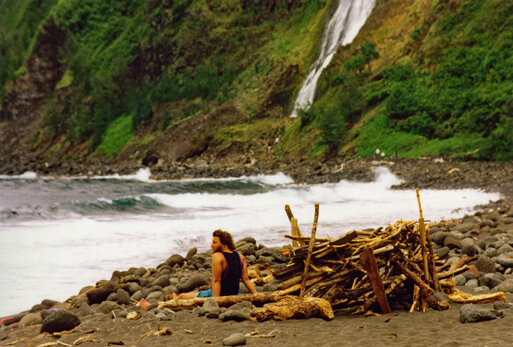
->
[273, 192, 505, 314]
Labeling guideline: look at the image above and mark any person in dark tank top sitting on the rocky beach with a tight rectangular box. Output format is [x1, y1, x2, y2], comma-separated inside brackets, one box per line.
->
[173, 229, 256, 300]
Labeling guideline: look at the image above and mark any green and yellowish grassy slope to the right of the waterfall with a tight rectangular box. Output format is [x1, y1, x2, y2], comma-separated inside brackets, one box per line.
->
[300, 0, 513, 159]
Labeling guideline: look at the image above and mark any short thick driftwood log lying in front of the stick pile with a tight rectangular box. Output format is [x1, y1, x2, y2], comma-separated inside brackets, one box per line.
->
[251, 296, 334, 322]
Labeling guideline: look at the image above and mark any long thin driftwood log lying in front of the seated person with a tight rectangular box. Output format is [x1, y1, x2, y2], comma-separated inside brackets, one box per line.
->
[159, 292, 284, 311]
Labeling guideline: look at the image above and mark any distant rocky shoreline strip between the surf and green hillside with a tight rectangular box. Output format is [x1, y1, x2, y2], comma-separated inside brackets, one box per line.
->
[0, 157, 513, 198]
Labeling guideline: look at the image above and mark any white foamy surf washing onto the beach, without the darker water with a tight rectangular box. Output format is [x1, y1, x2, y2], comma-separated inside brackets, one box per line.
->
[0, 168, 500, 316]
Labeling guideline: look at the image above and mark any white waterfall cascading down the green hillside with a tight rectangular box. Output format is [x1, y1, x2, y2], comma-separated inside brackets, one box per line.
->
[291, 0, 376, 117]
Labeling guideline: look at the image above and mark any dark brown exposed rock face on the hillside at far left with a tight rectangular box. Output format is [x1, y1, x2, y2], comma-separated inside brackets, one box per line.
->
[0, 20, 66, 121]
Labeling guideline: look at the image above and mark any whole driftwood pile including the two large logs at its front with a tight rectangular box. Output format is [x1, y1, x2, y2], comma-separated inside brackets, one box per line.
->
[159, 190, 506, 321]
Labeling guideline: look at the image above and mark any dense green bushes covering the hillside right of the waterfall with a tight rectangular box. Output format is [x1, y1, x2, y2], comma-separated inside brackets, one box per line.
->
[288, 1, 513, 160]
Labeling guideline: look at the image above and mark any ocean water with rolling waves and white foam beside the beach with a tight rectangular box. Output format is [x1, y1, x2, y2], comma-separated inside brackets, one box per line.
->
[0, 168, 500, 317]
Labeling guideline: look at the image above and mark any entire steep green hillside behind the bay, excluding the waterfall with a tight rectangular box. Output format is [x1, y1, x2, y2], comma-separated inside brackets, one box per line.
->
[0, 0, 513, 170]
